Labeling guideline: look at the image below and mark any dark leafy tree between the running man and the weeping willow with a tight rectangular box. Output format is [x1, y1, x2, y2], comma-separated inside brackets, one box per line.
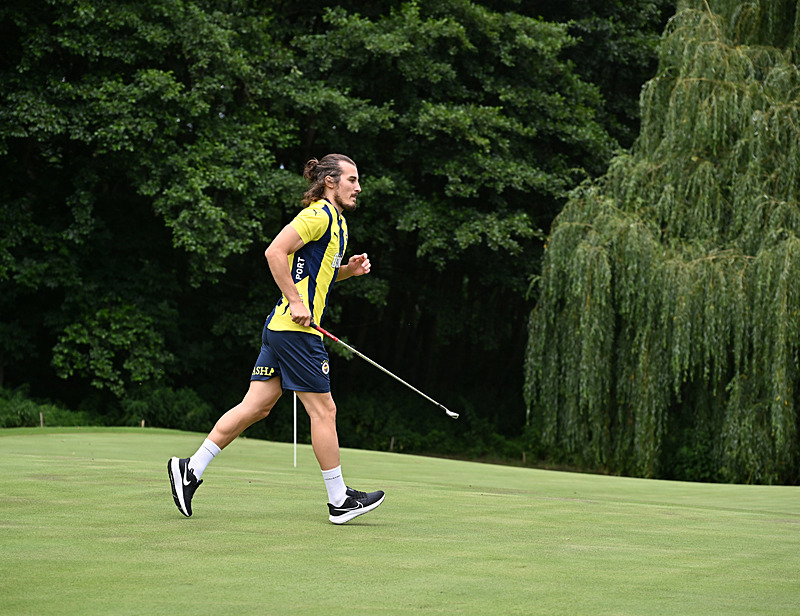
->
[276, 0, 628, 440]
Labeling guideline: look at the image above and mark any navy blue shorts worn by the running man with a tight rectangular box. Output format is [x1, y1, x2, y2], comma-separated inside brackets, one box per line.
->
[250, 324, 331, 393]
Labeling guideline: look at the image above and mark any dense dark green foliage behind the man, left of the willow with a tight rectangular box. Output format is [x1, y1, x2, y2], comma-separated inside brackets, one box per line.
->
[0, 0, 670, 458]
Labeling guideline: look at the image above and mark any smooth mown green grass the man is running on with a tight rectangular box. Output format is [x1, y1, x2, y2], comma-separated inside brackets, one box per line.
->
[0, 428, 800, 616]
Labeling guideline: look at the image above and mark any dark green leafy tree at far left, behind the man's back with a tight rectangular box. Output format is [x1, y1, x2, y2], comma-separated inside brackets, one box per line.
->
[0, 0, 293, 395]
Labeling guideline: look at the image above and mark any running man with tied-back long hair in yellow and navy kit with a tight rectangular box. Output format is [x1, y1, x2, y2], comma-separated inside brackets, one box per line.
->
[167, 154, 384, 524]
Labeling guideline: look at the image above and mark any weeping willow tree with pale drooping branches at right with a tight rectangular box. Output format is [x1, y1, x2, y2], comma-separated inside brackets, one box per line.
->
[525, 0, 800, 483]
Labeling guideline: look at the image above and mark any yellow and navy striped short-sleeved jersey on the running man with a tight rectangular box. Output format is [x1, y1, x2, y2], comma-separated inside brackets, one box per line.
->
[267, 199, 347, 336]
